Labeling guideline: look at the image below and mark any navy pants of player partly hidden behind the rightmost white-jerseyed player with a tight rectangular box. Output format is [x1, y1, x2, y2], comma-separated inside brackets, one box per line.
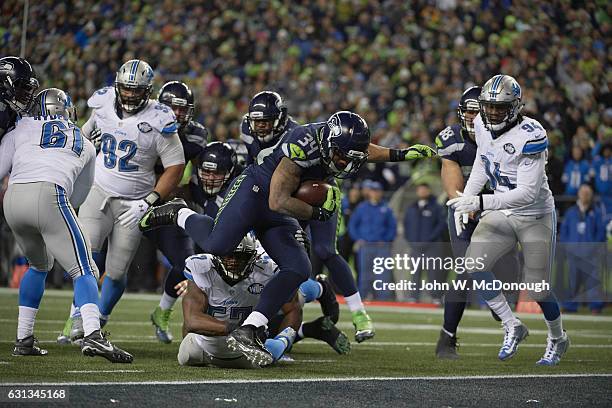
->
[443, 209, 521, 333]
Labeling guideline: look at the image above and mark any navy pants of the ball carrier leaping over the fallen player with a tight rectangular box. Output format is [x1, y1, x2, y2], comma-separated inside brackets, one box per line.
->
[185, 170, 311, 320]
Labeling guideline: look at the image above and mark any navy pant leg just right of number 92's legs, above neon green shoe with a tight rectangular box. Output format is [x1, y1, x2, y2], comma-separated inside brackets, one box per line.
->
[144, 225, 193, 298]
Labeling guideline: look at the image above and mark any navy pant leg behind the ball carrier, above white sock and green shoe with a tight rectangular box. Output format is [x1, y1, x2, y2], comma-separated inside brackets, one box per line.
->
[307, 212, 357, 297]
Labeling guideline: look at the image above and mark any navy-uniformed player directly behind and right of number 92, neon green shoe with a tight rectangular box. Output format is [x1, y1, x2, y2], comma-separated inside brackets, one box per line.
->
[145, 81, 208, 343]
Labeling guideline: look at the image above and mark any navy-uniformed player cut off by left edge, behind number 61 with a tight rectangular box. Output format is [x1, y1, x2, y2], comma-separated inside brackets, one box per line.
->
[0, 57, 38, 140]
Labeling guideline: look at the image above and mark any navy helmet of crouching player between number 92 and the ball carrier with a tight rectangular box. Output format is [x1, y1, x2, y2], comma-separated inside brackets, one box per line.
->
[197, 142, 236, 196]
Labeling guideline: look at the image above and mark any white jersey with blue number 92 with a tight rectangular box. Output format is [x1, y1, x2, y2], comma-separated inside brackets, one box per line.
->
[87, 87, 185, 199]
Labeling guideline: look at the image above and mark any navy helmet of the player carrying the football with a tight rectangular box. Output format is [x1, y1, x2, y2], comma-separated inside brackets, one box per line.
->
[318, 111, 370, 178]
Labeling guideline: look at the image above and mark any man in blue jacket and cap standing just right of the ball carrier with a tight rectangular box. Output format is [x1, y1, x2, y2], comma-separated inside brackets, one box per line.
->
[349, 180, 397, 300]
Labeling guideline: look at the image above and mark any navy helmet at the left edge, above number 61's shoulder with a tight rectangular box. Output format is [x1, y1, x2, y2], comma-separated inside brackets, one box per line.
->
[0, 57, 39, 113]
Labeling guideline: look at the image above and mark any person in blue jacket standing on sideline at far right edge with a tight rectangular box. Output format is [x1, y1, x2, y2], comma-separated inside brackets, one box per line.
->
[560, 184, 606, 314]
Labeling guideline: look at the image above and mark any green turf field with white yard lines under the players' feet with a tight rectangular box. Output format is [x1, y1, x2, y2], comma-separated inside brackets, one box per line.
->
[0, 289, 612, 383]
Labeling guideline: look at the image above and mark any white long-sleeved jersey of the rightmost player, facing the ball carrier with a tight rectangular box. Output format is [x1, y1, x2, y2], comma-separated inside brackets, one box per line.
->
[464, 115, 555, 215]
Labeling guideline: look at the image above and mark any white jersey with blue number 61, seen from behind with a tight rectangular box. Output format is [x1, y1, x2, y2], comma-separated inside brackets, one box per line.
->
[0, 115, 96, 197]
